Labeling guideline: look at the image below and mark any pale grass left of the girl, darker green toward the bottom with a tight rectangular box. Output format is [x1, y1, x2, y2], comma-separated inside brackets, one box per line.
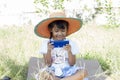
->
[0, 26, 40, 80]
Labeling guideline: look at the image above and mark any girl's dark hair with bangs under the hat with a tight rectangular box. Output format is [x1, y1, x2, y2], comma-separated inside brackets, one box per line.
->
[48, 20, 69, 39]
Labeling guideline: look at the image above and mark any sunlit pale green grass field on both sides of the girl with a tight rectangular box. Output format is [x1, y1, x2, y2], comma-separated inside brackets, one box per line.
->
[0, 24, 120, 80]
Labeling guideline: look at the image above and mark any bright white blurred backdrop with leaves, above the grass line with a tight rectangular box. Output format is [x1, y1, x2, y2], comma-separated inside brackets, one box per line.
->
[0, 0, 120, 27]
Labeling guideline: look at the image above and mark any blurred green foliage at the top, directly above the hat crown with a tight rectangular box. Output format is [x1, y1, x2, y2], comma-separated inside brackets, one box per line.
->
[34, 0, 64, 14]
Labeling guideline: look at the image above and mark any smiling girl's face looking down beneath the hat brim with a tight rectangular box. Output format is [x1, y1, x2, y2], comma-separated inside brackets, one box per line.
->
[51, 25, 67, 40]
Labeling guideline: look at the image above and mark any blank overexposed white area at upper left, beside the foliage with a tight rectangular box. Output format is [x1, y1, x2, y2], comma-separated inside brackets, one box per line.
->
[0, 0, 35, 27]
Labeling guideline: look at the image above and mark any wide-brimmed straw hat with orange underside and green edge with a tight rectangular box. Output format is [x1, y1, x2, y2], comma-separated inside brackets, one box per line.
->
[34, 11, 82, 38]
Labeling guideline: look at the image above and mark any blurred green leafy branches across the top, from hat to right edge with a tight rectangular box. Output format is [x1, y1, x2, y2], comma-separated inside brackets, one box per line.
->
[34, 0, 120, 28]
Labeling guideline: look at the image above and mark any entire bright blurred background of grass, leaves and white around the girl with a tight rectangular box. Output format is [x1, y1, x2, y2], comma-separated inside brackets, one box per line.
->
[0, 0, 120, 80]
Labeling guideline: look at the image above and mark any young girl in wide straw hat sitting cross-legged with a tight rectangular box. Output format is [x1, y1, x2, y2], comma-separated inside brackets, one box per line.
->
[35, 12, 87, 80]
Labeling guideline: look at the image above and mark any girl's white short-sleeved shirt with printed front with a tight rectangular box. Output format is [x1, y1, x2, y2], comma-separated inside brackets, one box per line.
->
[40, 39, 80, 65]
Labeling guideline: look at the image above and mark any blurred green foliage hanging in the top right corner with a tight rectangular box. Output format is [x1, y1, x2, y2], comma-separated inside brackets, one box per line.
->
[96, 0, 120, 28]
